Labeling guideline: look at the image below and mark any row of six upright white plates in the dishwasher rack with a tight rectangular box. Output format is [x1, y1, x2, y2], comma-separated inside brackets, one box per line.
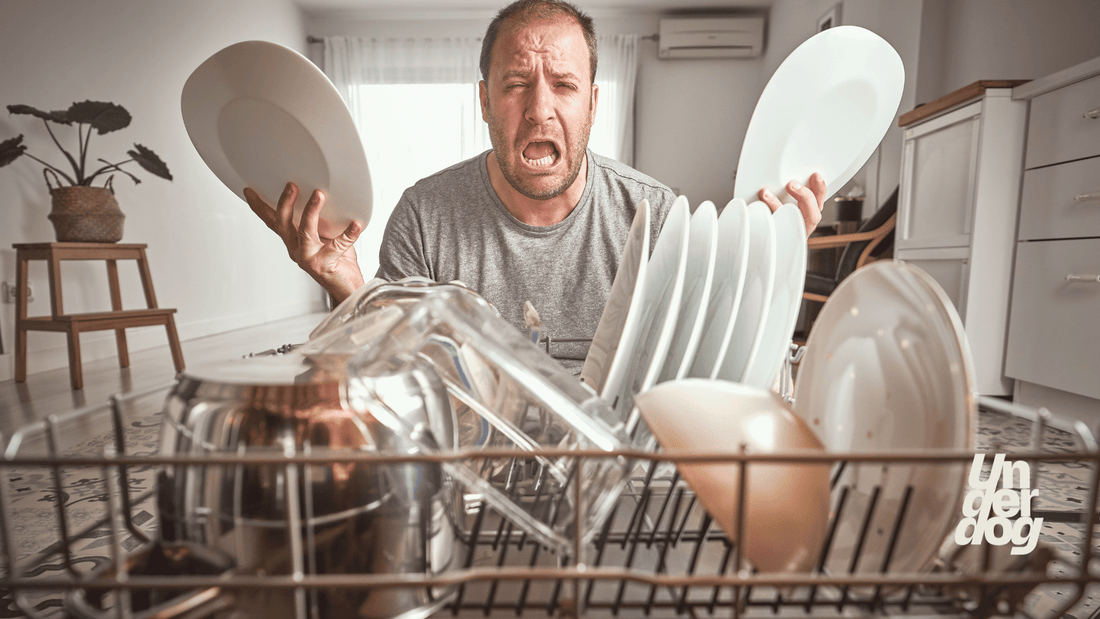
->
[581, 197, 806, 430]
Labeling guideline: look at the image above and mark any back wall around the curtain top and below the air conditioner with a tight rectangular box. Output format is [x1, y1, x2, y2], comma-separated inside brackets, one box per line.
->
[307, 11, 762, 208]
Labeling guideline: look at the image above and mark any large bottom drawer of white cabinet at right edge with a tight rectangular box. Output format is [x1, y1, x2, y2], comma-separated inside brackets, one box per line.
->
[1004, 239, 1100, 398]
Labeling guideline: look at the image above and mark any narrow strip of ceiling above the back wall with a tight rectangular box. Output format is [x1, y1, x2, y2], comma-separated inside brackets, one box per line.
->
[294, 0, 773, 19]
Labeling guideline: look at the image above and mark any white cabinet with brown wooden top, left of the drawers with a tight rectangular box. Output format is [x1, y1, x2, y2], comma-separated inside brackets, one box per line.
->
[894, 82, 1027, 396]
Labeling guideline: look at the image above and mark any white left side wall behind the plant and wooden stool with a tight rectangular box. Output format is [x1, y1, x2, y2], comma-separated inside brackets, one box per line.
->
[0, 0, 322, 380]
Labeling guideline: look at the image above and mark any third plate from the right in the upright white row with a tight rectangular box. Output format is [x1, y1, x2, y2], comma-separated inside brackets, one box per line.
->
[689, 198, 749, 378]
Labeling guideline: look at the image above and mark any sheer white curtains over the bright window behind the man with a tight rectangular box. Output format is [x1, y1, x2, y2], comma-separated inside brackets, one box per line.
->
[323, 34, 639, 277]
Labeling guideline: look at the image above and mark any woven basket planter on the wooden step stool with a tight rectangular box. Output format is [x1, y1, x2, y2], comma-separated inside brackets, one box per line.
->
[48, 187, 127, 243]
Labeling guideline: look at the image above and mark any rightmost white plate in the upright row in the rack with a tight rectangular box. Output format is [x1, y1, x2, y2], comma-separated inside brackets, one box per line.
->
[741, 205, 806, 389]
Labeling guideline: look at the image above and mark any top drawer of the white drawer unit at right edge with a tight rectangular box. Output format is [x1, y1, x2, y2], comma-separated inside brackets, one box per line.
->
[1025, 76, 1100, 169]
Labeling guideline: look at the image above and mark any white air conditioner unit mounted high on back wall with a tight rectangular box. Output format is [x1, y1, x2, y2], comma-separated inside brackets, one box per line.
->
[657, 18, 763, 58]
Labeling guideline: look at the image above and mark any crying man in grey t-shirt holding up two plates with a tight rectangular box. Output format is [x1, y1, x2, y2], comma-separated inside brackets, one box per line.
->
[245, 0, 825, 369]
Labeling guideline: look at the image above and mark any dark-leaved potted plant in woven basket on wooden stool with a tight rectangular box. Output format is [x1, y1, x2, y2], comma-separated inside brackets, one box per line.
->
[0, 101, 172, 243]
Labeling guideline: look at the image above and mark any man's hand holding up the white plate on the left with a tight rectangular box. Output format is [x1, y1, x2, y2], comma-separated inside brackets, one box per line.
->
[244, 183, 363, 302]
